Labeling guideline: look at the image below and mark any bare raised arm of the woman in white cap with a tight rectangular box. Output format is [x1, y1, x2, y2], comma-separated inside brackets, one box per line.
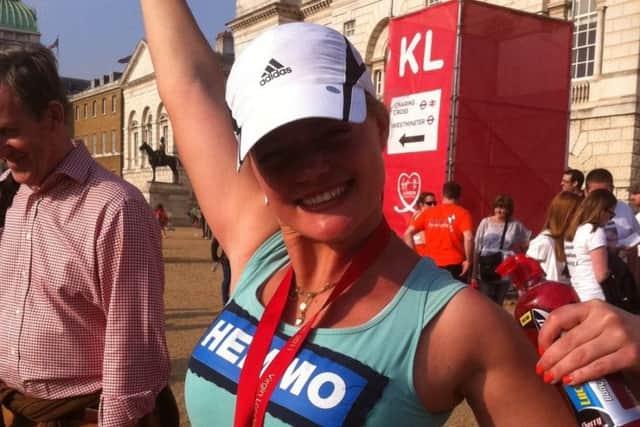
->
[141, 0, 277, 277]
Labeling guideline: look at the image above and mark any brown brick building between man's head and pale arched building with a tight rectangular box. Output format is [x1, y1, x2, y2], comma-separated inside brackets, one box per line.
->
[70, 73, 123, 176]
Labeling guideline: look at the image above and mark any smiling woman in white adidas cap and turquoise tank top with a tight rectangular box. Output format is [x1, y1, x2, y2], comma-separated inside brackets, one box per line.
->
[141, 0, 574, 427]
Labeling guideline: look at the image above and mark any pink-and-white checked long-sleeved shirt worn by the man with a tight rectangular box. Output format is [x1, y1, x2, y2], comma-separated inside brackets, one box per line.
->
[0, 144, 169, 427]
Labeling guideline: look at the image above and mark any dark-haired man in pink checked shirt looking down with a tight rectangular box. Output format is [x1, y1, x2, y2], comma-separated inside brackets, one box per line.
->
[0, 45, 177, 427]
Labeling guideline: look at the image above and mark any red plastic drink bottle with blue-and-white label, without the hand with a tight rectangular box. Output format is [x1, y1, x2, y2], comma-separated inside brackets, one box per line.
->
[496, 254, 640, 427]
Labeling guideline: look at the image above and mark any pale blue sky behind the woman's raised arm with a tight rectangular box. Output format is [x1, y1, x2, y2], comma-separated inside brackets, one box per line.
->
[28, 0, 235, 79]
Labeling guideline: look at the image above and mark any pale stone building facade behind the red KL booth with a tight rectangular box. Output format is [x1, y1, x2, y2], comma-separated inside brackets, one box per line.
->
[227, 0, 640, 198]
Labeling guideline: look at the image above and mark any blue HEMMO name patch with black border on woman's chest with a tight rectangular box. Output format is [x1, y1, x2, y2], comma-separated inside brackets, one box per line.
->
[189, 301, 388, 427]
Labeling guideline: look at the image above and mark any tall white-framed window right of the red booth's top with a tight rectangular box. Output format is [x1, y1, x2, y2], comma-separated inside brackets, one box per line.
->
[571, 0, 598, 79]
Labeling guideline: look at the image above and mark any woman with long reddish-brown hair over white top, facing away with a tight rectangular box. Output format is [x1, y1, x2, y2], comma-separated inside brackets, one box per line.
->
[527, 191, 582, 283]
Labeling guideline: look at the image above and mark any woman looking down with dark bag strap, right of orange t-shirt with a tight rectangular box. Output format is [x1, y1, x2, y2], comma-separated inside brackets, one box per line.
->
[471, 194, 531, 306]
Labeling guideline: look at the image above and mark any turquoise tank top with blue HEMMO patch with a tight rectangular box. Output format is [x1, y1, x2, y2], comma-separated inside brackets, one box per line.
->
[185, 233, 465, 427]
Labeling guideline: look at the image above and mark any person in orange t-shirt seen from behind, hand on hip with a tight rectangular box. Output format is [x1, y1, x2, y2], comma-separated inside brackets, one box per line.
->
[404, 181, 473, 279]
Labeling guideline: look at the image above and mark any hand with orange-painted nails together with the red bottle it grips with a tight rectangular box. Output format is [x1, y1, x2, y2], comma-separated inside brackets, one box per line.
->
[496, 255, 640, 427]
